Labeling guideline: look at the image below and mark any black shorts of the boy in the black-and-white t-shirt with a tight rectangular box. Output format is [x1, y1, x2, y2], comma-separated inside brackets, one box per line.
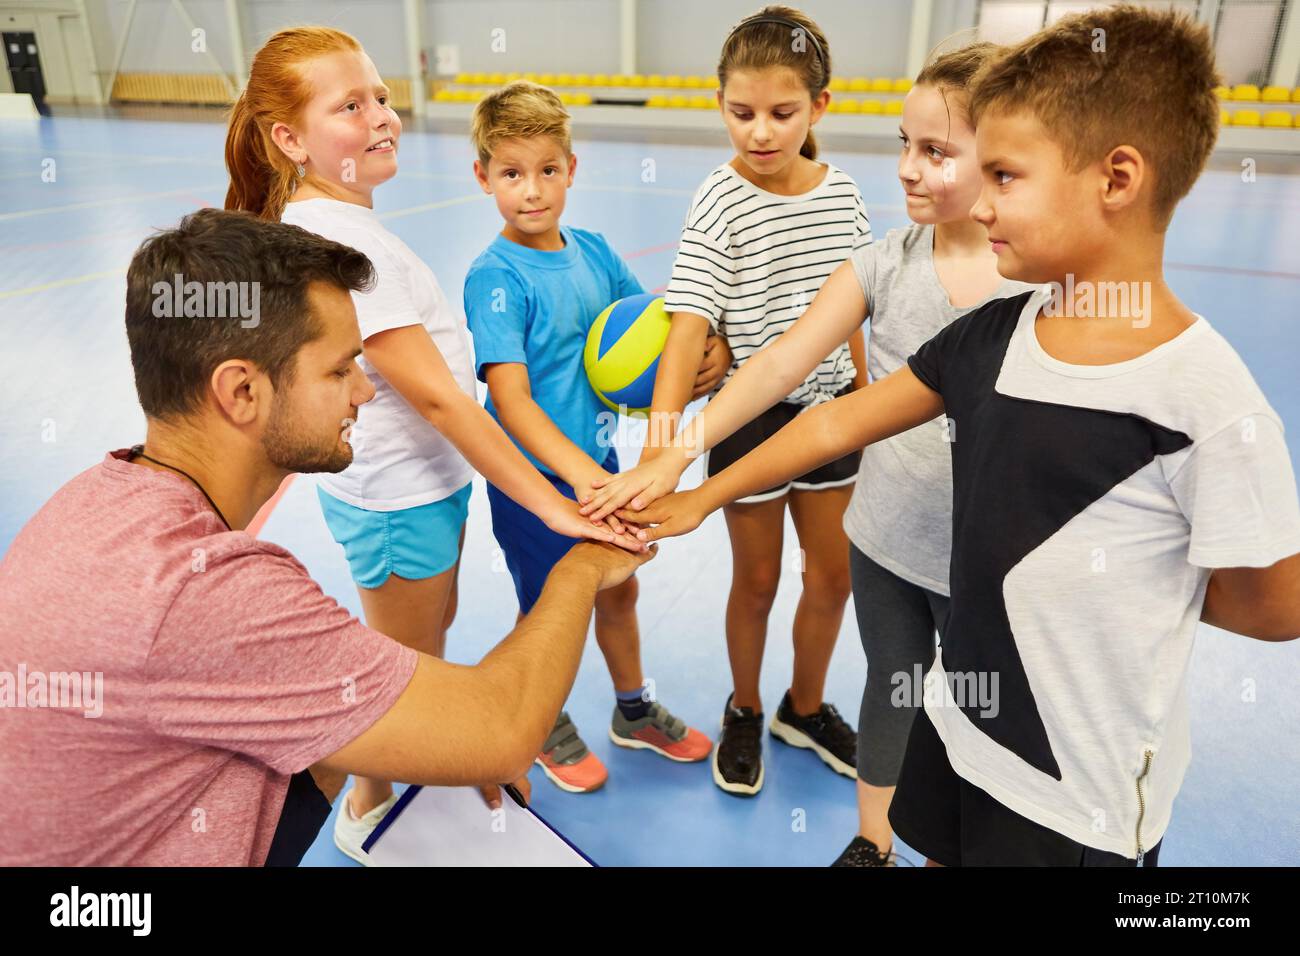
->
[889, 709, 1160, 866]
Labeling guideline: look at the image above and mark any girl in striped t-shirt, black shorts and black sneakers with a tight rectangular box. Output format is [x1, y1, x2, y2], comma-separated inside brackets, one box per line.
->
[586, 5, 871, 795]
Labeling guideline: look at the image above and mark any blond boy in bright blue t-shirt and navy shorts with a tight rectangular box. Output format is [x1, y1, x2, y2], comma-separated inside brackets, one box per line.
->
[465, 81, 729, 793]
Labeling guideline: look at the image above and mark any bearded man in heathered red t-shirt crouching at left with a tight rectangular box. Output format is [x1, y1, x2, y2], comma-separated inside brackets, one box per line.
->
[0, 209, 650, 866]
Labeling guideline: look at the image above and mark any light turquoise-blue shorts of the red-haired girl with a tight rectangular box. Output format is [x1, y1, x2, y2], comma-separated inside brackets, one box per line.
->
[316, 485, 472, 588]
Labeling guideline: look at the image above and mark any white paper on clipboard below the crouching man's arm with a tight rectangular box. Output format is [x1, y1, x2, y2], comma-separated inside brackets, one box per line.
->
[368, 787, 592, 866]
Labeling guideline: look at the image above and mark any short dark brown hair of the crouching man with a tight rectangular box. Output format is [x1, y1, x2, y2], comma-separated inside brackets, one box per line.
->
[126, 209, 374, 420]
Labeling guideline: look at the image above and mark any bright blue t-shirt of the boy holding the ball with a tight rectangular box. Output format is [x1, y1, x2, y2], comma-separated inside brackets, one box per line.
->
[465, 226, 645, 475]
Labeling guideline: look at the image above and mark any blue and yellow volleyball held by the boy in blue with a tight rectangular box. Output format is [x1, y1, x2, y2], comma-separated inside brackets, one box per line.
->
[582, 293, 670, 418]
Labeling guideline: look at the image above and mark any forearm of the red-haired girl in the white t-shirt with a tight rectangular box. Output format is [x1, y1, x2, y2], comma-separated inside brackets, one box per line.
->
[428, 390, 559, 515]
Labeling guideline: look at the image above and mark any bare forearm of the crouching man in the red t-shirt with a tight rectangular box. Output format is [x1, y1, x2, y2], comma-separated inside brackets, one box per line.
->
[478, 551, 601, 757]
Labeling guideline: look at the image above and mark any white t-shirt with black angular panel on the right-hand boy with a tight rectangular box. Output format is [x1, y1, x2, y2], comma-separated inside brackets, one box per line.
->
[909, 290, 1300, 858]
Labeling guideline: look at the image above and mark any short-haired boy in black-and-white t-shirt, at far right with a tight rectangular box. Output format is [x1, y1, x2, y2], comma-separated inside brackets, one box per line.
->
[620, 7, 1300, 866]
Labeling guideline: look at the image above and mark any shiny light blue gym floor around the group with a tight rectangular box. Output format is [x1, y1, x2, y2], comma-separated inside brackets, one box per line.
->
[0, 116, 1300, 866]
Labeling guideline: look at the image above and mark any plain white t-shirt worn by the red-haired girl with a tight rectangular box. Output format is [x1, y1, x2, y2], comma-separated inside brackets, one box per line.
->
[281, 199, 477, 511]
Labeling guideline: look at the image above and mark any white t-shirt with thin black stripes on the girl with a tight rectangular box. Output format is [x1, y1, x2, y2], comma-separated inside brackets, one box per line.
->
[664, 163, 871, 405]
